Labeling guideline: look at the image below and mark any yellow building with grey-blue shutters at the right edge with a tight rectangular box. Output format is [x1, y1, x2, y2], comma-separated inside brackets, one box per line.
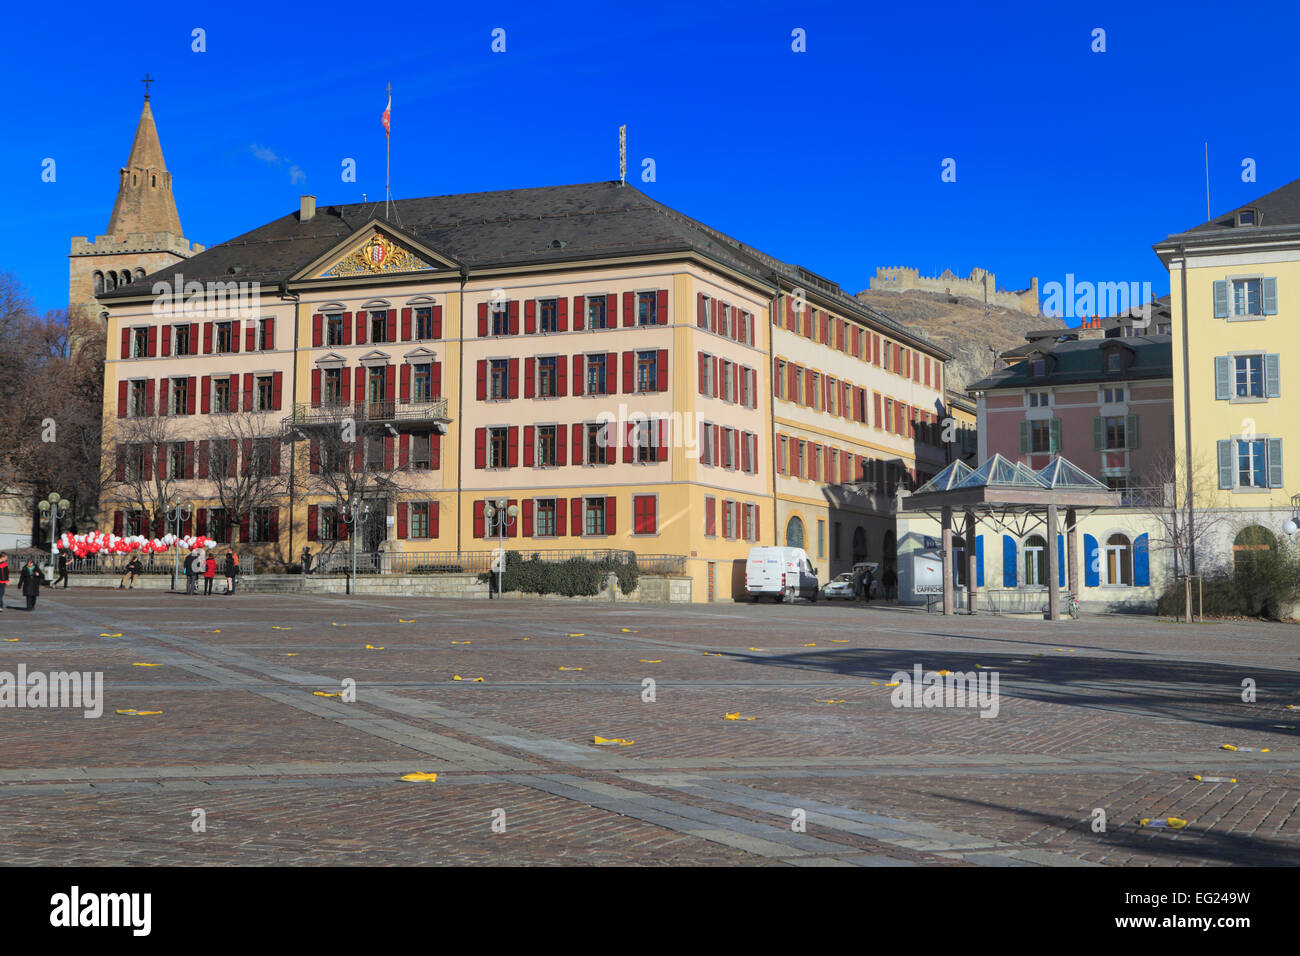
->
[1154, 181, 1300, 571]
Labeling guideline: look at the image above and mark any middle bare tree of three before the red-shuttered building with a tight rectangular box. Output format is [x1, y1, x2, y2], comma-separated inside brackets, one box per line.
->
[199, 412, 290, 557]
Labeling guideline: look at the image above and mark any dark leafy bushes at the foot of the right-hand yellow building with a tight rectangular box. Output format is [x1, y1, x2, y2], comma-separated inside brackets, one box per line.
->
[1157, 538, 1300, 618]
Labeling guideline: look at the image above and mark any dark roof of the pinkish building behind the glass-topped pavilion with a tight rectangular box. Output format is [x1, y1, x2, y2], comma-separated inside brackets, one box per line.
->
[966, 329, 1174, 392]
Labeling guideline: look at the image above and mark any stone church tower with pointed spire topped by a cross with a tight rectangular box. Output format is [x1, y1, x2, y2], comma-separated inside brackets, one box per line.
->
[68, 87, 203, 332]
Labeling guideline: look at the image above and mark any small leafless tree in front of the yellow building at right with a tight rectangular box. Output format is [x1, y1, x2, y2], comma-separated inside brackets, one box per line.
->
[1136, 449, 1230, 620]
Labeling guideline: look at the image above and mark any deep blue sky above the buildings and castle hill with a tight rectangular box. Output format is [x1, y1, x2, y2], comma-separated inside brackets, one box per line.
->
[10, 0, 1300, 316]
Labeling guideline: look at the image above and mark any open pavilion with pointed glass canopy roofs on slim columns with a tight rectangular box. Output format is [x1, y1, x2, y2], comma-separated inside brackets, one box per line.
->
[902, 454, 1121, 620]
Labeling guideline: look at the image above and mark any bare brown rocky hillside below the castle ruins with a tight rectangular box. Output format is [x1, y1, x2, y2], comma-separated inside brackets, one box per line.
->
[857, 290, 1066, 390]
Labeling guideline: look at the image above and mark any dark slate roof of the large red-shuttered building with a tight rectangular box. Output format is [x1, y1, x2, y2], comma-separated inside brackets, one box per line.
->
[99, 182, 952, 358]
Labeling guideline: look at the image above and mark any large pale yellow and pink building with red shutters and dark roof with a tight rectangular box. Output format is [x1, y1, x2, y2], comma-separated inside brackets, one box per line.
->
[91, 182, 948, 601]
